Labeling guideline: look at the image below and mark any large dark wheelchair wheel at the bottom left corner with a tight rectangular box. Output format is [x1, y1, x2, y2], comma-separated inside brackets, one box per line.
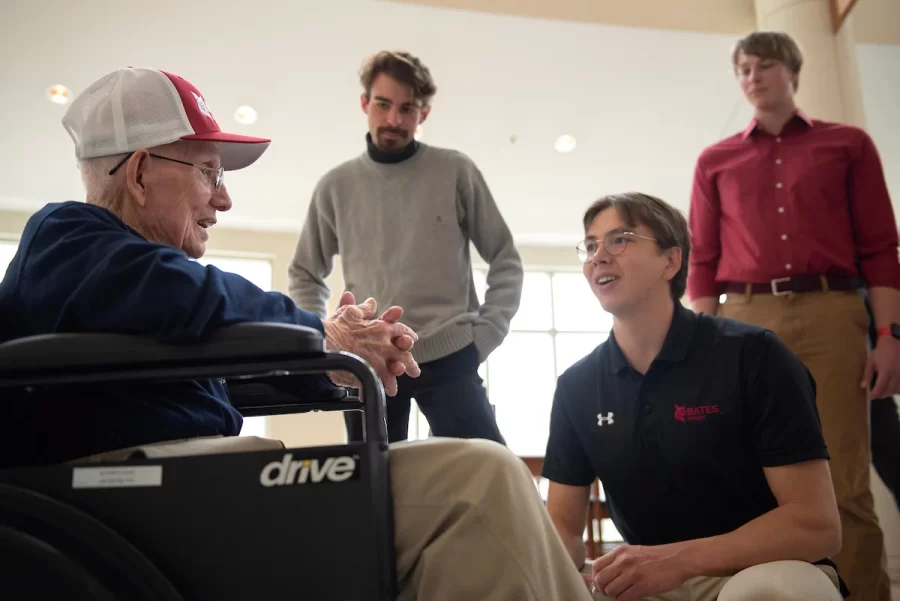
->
[0, 484, 182, 601]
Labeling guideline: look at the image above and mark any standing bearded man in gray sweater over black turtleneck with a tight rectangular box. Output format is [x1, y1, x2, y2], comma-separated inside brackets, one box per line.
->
[289, 52, 523, 443]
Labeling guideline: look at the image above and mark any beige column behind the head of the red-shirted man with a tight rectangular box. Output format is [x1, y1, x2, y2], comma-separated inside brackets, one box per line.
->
[756, 0, 865, 127]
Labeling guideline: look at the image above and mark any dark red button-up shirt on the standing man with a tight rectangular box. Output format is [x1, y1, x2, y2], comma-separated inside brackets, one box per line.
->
[687, 111, 900, 298]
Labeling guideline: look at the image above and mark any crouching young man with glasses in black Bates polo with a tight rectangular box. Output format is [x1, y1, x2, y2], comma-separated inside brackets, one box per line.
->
[543, 194, 842, 601]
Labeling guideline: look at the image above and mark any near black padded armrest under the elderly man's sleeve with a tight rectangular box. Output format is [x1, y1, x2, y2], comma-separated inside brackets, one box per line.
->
[0, 323, 325, 376]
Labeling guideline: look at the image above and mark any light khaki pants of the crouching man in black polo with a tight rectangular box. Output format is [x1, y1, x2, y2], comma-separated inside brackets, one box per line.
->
[594, 561, 842, 601]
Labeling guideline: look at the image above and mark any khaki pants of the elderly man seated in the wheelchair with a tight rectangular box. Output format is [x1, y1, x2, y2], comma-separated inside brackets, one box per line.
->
[78, 437, 591, 601]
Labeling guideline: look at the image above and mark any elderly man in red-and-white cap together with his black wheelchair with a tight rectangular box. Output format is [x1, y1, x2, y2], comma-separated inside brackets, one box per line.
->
[0, 68, 590, 601]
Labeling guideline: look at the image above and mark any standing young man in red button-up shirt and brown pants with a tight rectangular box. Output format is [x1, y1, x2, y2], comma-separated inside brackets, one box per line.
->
[688, 32, 900, 601]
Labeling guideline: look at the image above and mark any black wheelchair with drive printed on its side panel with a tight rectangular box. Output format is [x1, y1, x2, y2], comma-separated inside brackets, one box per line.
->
[0, 323, 397, 601]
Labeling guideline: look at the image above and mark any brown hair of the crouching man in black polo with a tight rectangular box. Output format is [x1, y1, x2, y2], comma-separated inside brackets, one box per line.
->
[583, 192, 691, 301]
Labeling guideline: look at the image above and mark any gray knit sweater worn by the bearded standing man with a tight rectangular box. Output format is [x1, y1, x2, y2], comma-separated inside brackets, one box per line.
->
[289, 144, 523, 363]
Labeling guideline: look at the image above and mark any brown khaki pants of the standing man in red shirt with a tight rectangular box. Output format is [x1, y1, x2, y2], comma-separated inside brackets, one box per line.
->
[719, 291, 891, 601]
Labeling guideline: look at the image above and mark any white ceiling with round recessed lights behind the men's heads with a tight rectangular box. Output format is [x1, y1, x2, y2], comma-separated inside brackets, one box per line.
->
[0, 0, 824, 244]
